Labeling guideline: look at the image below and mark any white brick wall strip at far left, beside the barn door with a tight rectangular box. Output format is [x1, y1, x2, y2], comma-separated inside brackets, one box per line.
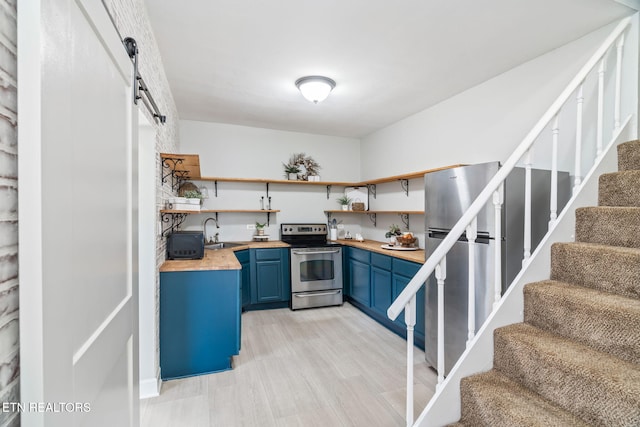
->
[0, 0, 20, 427]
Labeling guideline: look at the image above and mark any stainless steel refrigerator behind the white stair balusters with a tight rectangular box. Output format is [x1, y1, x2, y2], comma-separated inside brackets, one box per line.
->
[425, 162, 571, 375]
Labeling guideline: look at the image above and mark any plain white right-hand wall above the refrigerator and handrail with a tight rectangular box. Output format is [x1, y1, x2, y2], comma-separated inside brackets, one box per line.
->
[361, 21, 612, 179]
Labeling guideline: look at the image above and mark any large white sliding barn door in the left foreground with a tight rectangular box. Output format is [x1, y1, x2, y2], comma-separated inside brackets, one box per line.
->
[18, 0, 139, 427]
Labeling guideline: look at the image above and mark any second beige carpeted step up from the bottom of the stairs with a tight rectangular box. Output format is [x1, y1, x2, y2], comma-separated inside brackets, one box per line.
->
[494, 323, 640, 425]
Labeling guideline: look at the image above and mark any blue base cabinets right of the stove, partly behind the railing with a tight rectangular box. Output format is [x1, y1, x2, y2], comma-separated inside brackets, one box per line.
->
[344, 247, 425, 349]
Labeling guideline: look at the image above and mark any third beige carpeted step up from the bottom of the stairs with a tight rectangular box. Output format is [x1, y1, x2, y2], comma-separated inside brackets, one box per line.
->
[524, 280, 640, 364]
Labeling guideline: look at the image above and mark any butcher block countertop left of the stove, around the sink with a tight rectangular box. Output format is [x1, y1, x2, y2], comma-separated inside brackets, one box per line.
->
[160, 240, 289, 273]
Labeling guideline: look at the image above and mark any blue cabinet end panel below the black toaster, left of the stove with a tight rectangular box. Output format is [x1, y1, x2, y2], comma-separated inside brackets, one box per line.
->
[160, 270, 241, 380]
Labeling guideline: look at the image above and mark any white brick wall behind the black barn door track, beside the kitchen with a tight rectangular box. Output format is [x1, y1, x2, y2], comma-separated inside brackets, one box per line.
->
[104, 0, 179, 388]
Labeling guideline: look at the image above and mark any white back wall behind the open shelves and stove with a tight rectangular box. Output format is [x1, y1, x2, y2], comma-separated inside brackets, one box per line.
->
[180, 120, 360, 241]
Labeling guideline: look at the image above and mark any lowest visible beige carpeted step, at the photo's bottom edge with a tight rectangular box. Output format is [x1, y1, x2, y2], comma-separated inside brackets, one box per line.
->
[460, 370, 588, 427]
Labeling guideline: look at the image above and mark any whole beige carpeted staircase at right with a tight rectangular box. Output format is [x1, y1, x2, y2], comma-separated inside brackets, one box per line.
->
[454, 141, 640, 427]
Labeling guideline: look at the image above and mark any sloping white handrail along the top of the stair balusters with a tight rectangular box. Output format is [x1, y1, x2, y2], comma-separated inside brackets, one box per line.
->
[387, 17, 631, 320]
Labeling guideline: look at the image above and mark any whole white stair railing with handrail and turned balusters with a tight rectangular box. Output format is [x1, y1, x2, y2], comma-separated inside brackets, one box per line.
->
[387, 17, 631, 426]
